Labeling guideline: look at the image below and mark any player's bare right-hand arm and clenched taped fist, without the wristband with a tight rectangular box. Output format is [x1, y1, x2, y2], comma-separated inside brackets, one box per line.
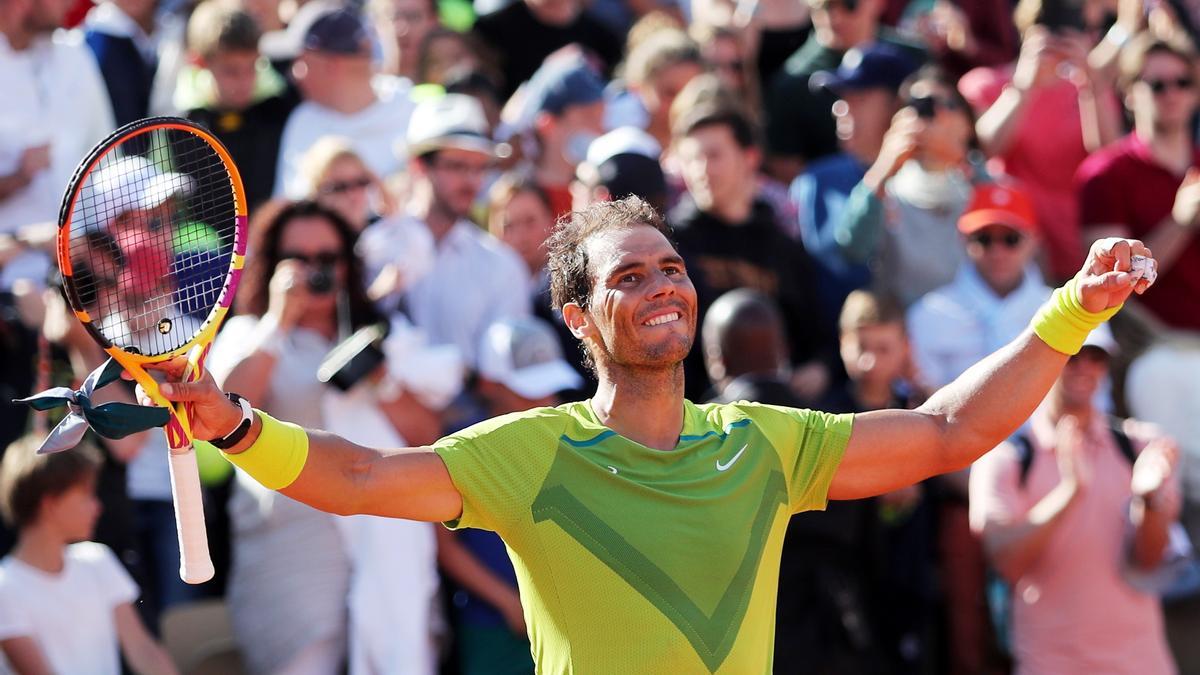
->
[829, 239, 1150, 500]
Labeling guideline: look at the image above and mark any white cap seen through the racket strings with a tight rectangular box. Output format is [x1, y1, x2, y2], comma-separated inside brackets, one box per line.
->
[76, 155, 196, 229]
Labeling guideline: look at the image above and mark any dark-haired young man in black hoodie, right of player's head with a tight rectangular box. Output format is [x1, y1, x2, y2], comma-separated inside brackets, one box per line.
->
[670, 106, 834, 400]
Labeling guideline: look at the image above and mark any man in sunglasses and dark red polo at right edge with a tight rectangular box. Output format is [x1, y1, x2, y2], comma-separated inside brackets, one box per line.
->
[1078, 34, 1200, 331]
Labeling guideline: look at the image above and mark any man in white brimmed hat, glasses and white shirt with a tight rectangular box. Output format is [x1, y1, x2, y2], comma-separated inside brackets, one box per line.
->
[359, 94, 529, 369]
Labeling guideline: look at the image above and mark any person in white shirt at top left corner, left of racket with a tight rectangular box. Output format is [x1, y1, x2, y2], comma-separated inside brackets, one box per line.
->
[0, 0, 113, 283]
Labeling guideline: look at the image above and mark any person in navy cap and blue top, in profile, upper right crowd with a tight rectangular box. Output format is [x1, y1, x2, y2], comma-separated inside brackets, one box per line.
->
[791, 42, 917, 325]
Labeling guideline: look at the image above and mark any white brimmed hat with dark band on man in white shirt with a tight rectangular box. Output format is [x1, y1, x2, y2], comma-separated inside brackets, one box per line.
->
[406, 94, 497, 157]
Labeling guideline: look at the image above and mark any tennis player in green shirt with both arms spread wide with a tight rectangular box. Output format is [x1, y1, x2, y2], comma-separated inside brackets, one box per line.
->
[147, 197, 1150, 674]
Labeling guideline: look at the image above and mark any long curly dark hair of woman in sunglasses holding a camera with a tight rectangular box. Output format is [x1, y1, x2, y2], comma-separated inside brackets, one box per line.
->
[236, 199, 383, 329]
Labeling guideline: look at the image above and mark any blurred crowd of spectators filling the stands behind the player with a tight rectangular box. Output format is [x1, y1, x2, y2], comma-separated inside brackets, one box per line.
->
[0, 0, 1200, 674]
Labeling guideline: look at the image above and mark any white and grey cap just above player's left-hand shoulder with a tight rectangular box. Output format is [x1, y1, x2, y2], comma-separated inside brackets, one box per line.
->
[479, 316, 583, 399]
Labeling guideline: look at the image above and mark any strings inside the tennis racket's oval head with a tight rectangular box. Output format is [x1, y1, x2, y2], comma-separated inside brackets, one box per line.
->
[70, 129, 236, 356]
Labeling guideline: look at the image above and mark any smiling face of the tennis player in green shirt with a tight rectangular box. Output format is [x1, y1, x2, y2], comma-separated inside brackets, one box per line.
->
[577, 226, 696, 369]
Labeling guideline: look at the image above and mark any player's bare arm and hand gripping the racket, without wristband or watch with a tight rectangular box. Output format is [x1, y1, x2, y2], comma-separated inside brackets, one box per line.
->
[139, 359, 462, 521]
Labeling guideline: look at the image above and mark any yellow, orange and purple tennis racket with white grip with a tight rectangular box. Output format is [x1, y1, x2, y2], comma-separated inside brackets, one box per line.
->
[58, 118, 246, 584]
